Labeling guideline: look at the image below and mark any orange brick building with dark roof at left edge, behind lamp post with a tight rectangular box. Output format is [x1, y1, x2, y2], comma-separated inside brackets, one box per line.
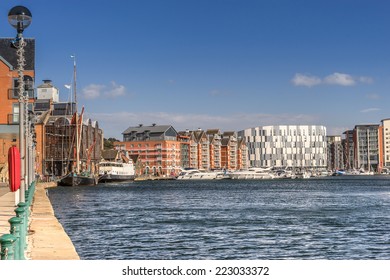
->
[0, 38, 35, 182]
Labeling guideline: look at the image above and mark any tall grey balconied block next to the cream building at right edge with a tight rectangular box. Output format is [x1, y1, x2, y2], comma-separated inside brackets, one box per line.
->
[354, 124, 380, 171]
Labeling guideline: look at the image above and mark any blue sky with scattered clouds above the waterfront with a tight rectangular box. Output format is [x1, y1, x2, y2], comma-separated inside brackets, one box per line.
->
[0, 0, 390, 139]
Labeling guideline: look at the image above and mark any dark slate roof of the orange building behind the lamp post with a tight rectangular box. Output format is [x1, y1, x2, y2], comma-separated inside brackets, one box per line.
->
[0, 38, 35, 70]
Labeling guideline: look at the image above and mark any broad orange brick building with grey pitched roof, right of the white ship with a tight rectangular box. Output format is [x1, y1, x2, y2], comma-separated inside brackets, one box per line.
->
[114, 124, 181, 176]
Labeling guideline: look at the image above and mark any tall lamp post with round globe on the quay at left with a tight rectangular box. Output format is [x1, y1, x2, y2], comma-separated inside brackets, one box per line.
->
[8, 6, 32, 202]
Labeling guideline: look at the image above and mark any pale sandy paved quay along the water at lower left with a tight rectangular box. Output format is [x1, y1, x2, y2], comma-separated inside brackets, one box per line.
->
[0, 183, 80, 260]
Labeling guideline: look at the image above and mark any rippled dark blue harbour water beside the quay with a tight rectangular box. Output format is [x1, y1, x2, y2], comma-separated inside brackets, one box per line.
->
[49, 176, 390, 260]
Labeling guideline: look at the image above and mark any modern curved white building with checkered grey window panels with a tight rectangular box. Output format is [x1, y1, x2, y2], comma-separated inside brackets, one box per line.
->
[238, 125, 327, 168]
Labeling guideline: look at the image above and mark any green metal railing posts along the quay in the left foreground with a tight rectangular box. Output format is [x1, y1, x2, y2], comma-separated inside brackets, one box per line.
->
[0, 181, 35, 260]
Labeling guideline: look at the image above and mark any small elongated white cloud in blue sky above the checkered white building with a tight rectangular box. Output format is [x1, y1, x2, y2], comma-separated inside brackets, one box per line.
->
[291, 72, 374, 87]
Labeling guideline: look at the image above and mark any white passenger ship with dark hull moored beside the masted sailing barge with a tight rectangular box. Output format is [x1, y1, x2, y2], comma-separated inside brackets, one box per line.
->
[99, 159, 135, 183]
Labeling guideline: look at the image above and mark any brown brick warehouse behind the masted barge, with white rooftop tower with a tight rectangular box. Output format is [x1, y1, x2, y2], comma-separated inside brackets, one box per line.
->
[34, 80, 103, 178]
